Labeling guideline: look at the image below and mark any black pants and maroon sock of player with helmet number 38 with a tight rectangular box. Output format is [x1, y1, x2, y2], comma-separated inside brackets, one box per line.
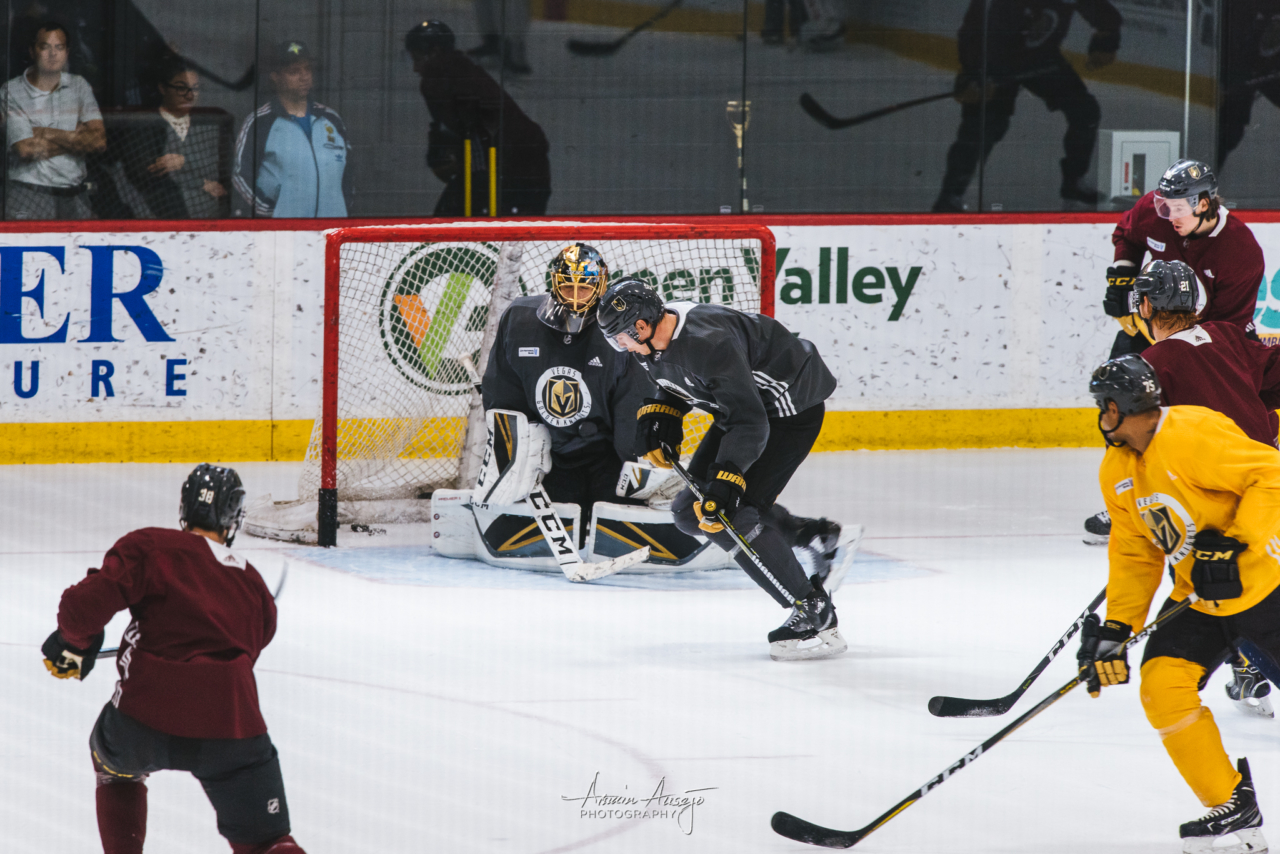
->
[90, 703, 289, 854]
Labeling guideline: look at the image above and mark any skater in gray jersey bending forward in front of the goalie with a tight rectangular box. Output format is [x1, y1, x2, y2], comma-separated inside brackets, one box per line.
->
[596, 279, 849, 661]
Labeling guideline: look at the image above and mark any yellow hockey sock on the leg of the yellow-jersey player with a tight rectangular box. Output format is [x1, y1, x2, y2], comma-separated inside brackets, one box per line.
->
[1140, 656, 1240, 807]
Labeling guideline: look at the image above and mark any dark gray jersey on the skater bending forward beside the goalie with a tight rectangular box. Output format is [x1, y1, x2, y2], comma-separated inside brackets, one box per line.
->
[649, 302, 836, 471]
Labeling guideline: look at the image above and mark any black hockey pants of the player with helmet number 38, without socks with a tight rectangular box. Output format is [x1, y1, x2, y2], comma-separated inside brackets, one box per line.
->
[88, 703, 289, 845]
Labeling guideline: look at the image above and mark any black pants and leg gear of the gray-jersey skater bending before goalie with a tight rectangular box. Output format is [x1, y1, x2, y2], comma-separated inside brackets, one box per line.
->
[671, 403, 826, 608]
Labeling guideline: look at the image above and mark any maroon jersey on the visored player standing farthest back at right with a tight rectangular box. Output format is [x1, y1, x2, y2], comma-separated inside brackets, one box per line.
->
[1111, 192, 1266, 330]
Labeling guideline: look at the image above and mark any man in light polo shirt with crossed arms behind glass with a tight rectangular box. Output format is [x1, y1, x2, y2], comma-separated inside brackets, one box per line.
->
[0, 22, 106, 219]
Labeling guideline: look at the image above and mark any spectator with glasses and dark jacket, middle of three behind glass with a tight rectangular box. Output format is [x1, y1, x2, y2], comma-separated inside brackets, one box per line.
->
[113, 56, 230, 219]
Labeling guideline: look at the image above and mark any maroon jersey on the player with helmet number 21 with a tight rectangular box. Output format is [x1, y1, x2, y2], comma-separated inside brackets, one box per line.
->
[1142, 323, 1280, 447]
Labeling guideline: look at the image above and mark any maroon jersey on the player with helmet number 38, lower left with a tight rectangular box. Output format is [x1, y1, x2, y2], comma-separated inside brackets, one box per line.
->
[58, 528, 275, 739]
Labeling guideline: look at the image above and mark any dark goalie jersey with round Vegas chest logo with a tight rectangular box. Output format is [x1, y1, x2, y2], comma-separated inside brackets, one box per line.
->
[483, 296, 655, 467]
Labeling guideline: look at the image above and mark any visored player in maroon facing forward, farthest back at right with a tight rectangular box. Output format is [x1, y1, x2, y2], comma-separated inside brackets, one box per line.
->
[1102, 160, 1265, 359]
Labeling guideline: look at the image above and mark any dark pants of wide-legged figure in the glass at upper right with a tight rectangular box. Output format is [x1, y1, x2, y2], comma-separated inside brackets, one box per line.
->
[942, 59, 1102, 196]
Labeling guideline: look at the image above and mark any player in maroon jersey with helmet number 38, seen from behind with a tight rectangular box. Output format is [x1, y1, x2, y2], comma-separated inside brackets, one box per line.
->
[41, 465, 302, 854]
